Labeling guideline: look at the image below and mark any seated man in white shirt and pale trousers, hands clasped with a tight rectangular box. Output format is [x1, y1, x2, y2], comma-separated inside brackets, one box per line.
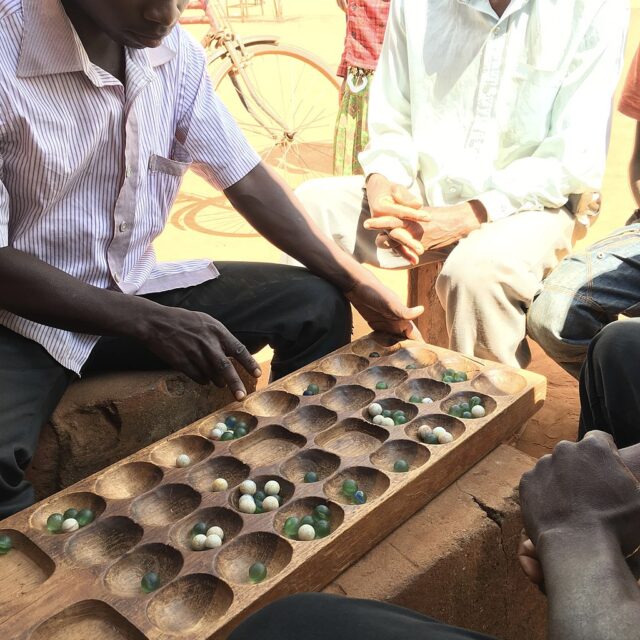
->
[290, 0, 629, 366]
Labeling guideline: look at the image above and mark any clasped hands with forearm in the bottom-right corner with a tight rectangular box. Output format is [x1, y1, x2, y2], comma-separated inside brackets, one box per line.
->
[520, 431, 640, 640]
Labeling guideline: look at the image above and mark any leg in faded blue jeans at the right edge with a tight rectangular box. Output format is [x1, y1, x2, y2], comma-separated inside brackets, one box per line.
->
[527, 224, 640, 378]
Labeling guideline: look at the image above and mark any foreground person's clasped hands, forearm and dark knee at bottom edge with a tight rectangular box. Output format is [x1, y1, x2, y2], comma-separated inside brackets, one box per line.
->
[229, 432, 640, 640]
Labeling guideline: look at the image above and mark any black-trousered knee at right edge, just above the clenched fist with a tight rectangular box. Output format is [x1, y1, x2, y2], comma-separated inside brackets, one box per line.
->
[579, 320, 640, 449]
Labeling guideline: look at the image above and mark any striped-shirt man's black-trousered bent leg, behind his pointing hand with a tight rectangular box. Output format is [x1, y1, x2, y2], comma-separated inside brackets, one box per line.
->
[83, 262, 352, 379]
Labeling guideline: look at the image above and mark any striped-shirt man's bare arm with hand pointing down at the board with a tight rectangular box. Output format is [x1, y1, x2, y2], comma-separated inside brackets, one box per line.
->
[0, 247, 260, 399]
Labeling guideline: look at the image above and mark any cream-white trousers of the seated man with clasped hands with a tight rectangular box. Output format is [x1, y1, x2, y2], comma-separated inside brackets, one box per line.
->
[284, 176, 576, 367]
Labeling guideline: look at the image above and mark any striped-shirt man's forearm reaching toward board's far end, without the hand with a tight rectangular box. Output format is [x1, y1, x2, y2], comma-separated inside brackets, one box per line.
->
[225, 164, 368, 291]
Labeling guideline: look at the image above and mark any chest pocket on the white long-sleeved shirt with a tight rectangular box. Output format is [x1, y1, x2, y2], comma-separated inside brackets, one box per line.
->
[509, 63, 562, 145]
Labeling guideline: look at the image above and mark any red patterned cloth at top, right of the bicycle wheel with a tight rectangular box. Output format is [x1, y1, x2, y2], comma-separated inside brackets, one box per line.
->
[338, 0, 391, 77]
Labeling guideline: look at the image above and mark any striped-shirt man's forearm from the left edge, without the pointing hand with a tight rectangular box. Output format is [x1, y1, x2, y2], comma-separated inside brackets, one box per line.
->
[0, 247, 156, 337]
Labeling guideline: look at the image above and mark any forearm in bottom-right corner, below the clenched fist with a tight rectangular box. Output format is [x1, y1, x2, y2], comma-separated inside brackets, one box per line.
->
[537, 531, 640, 640]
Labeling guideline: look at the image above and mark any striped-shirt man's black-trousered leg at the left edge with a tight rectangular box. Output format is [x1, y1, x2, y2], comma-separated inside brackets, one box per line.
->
[0, 327, 75, 520]
